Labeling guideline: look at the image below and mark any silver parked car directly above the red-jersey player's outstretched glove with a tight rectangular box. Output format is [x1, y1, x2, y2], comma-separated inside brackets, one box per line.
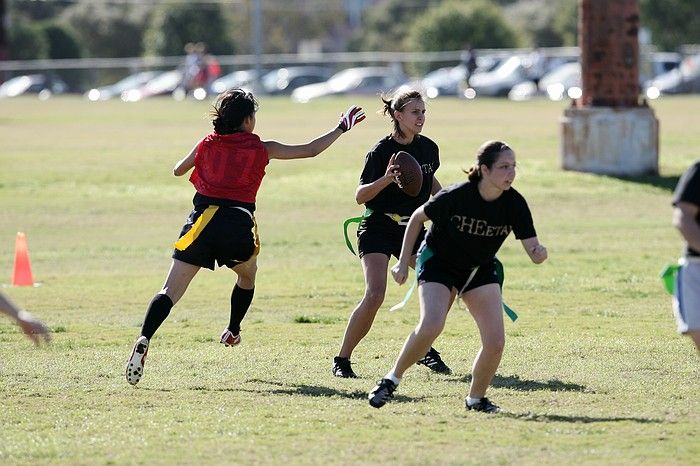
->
[292, 66, 406, 102]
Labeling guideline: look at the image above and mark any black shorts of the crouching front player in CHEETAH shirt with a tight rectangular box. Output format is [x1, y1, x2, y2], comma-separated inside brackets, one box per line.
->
[418, 246, 499, 295]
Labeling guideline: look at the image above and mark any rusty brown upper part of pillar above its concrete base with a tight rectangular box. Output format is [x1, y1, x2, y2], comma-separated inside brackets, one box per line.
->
[579, 0, 640, 107]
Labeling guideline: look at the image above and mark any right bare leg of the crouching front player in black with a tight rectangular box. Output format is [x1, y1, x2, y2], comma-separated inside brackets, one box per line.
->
[463, 283, 505, 398]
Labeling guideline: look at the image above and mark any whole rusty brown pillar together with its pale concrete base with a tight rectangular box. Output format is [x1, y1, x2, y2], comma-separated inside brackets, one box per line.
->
[561, 0, 659, 176]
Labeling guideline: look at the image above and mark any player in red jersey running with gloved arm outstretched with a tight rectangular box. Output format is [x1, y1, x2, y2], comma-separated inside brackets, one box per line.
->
[126, 89, 365, 385]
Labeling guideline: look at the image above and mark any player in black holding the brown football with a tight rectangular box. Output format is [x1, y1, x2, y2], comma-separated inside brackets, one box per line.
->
[332, 90, 451, 378]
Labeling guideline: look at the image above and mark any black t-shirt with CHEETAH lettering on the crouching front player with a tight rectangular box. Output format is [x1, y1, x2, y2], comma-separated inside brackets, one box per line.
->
[424, 182, 537, 270]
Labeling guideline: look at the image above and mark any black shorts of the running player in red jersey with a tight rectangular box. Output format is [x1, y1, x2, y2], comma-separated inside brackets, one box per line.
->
[172, 205, 260, 270]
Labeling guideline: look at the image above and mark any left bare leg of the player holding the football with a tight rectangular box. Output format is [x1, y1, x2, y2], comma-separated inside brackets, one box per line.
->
[338, 253, 389, 358]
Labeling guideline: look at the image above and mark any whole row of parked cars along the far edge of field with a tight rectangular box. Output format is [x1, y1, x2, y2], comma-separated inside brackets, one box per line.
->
[0, 53, 700, 102]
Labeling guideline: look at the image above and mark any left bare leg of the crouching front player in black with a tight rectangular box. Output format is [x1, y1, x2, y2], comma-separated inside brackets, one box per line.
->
[392, 282, 453, 378]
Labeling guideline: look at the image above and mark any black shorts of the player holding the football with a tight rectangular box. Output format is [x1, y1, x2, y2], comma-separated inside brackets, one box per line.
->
[357, 212, 425, 258]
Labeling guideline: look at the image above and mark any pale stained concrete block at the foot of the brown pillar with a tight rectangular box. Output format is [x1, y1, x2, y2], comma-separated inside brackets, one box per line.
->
[561, 107, 659, 176]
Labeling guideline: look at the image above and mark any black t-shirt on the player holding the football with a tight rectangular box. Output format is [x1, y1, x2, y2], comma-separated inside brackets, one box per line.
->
[360, 135, 440, 216]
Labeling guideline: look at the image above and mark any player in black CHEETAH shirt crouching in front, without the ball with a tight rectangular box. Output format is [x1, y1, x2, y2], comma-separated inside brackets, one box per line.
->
[369, 141, 547, 412]
